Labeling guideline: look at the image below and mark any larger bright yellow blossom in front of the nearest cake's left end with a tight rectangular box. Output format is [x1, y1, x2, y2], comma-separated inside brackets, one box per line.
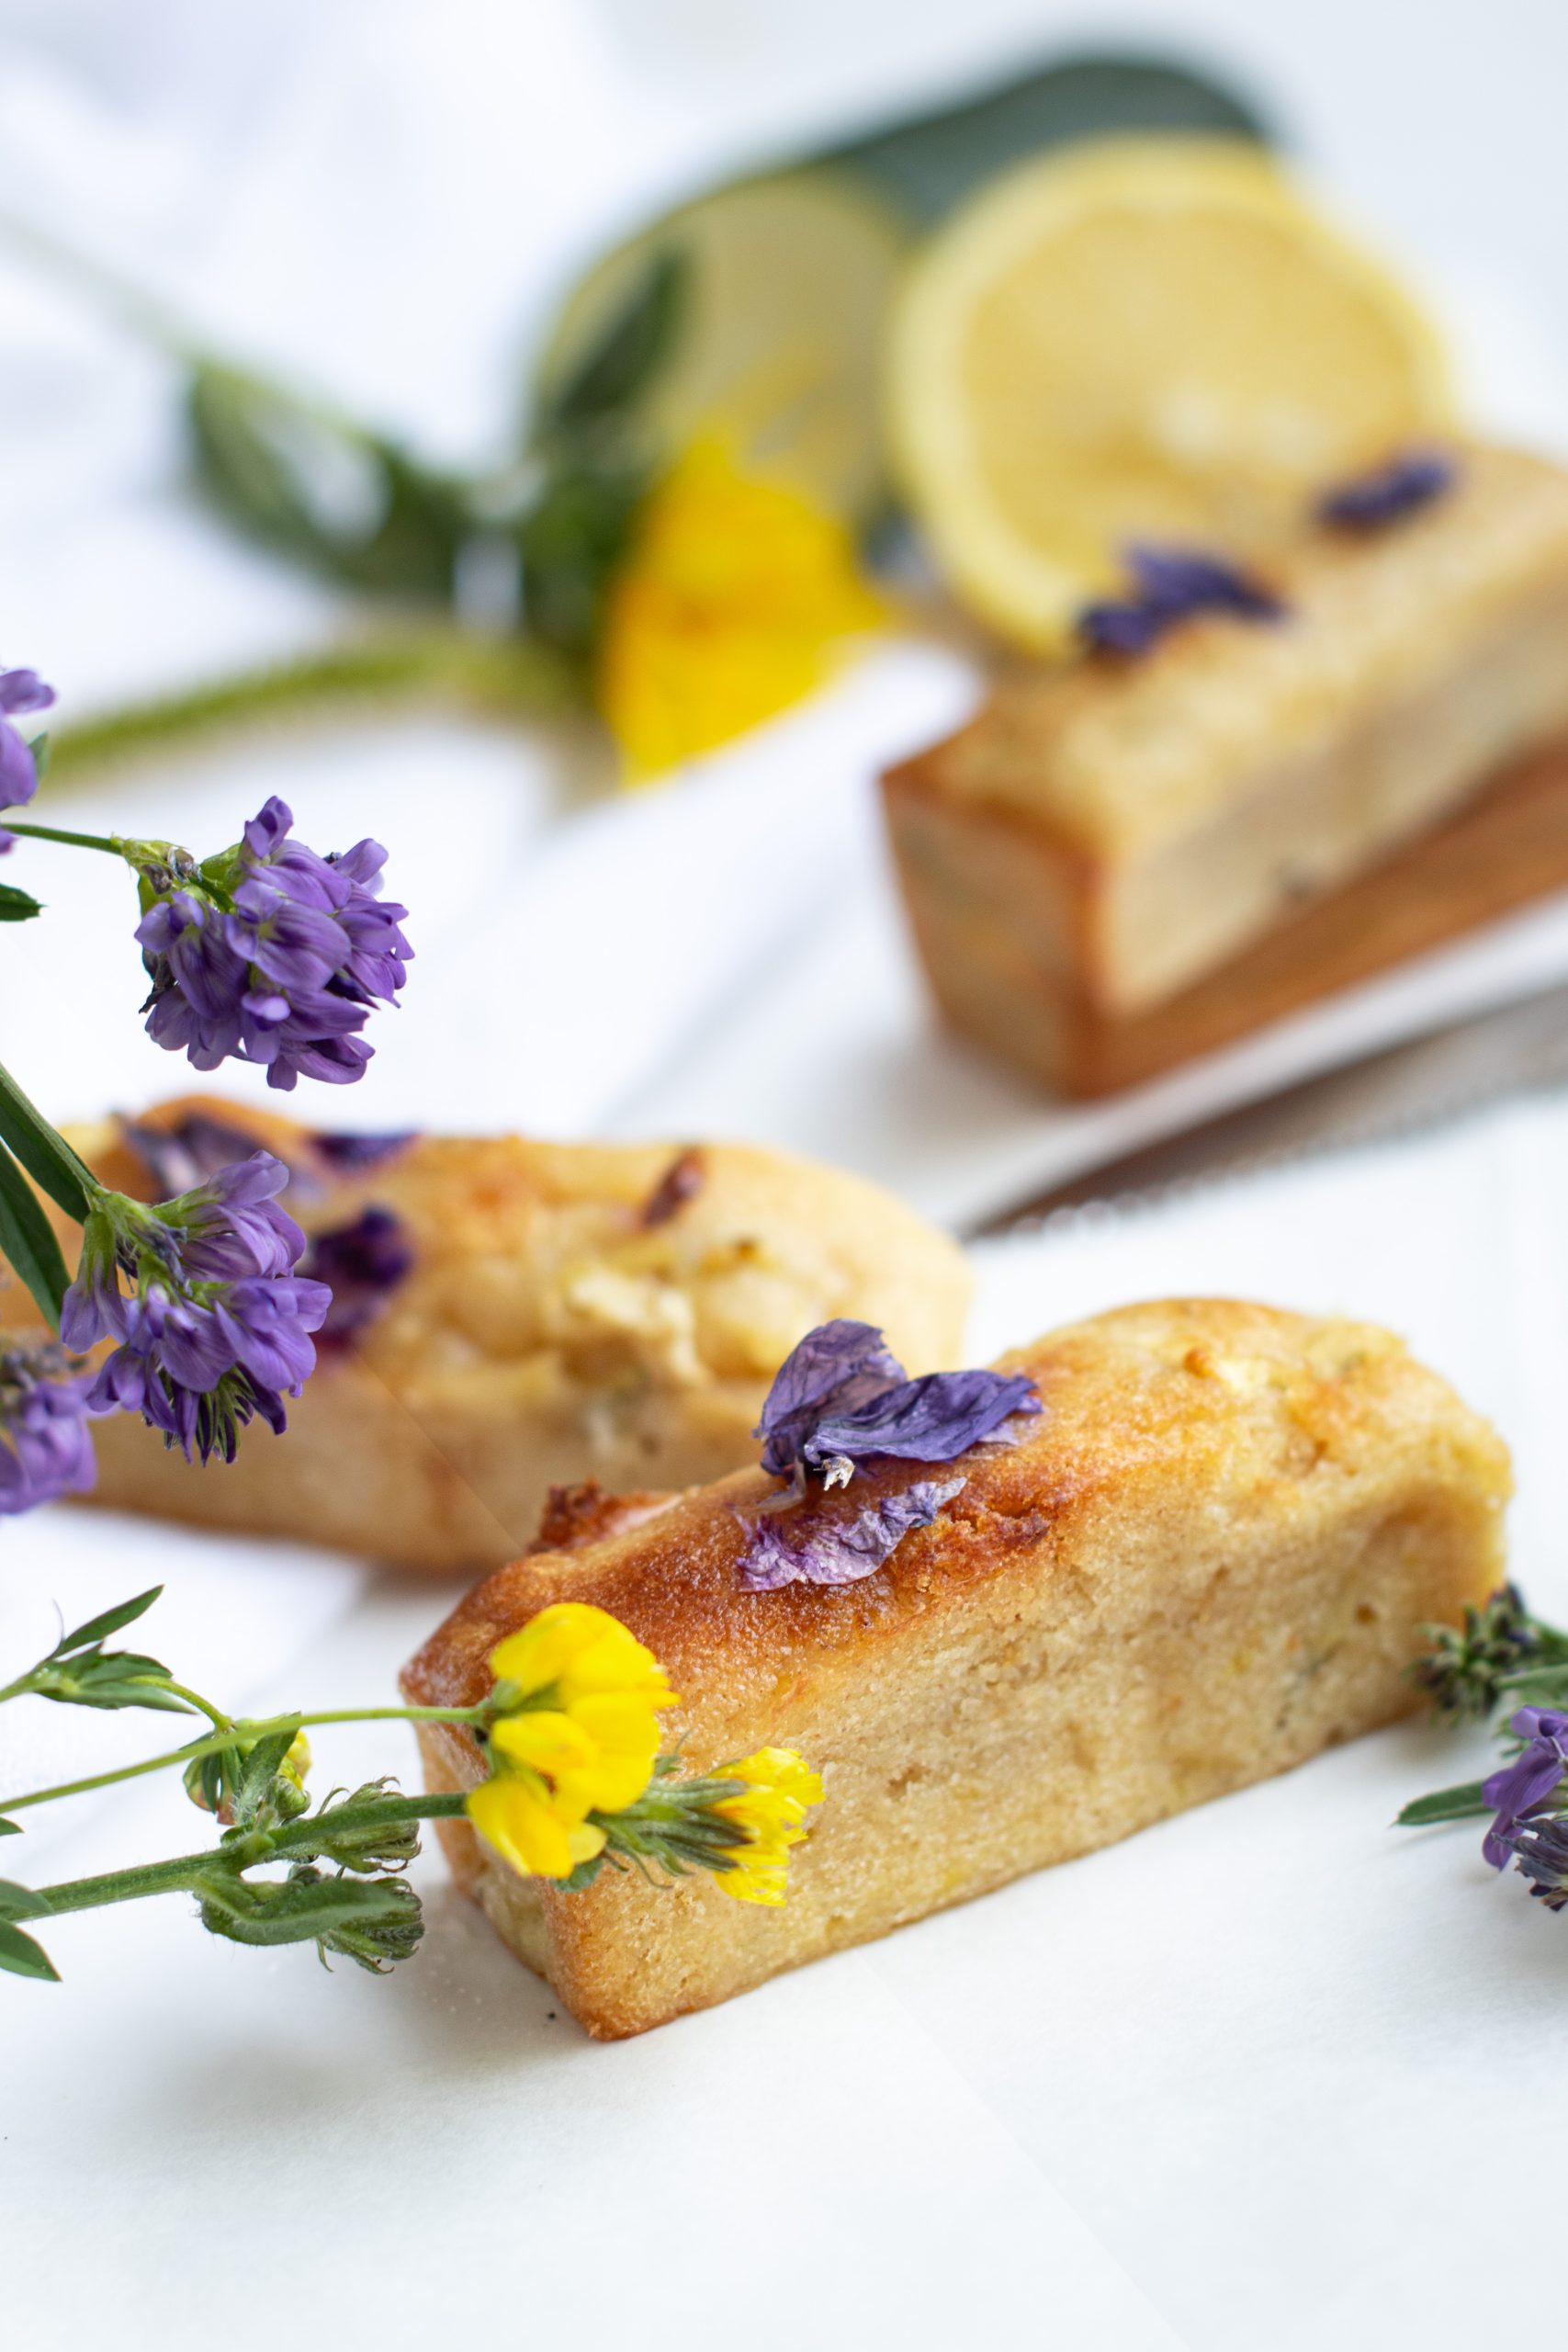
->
[468, 1601, 674, 1879]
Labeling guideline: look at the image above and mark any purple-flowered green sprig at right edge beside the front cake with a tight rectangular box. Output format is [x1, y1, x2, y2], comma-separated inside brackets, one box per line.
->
[1399, 1585, 1568, 1910]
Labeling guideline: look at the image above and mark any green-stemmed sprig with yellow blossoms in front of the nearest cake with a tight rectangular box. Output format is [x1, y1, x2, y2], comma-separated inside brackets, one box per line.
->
[0, 1588, 823, 1981]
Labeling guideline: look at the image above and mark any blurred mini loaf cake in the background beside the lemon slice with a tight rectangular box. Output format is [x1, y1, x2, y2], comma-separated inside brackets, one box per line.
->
[884, 447, 1568, 1093]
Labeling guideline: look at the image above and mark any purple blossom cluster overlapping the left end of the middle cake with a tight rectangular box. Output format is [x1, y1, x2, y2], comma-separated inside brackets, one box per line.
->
[62, 1152, 332, 1461]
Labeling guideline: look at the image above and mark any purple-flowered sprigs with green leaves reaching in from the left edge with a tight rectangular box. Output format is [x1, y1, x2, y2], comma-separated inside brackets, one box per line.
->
[0, 668, 412, 1515]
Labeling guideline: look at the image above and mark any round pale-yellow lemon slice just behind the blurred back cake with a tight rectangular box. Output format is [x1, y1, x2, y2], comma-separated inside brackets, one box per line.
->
[888, 136, 1450, 651]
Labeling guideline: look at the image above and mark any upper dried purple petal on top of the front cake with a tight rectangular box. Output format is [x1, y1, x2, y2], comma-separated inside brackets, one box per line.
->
[752, 1319, 1039, 1487]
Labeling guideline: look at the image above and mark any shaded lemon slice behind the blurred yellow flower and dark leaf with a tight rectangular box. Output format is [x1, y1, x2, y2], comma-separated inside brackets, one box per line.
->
[538, 172, 908, 520]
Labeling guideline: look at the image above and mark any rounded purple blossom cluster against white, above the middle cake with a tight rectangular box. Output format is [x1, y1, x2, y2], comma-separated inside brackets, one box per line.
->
[136, 797, 412, 1089]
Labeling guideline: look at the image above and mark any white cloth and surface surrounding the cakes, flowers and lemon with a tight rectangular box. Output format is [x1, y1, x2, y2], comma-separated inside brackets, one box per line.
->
[0, 0, 1568, 2352]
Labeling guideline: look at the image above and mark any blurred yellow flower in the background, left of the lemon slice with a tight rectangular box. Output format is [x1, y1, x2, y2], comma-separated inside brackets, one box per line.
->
[600, 430, 882, 783]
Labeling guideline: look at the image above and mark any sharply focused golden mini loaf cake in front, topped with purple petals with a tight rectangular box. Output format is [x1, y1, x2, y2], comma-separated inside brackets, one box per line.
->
[402, 1301, 1509, 2037]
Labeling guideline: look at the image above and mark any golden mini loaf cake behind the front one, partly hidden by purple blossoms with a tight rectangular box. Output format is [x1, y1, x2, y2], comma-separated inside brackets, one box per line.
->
[39, 1096, 968, 1574]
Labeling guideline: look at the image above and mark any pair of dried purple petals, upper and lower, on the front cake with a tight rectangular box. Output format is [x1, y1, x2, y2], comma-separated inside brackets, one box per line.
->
[740, 1319, 1042, 1592]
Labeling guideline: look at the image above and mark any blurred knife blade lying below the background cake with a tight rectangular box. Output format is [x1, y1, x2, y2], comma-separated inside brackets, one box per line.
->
[964, 986, 1568, 1239]
